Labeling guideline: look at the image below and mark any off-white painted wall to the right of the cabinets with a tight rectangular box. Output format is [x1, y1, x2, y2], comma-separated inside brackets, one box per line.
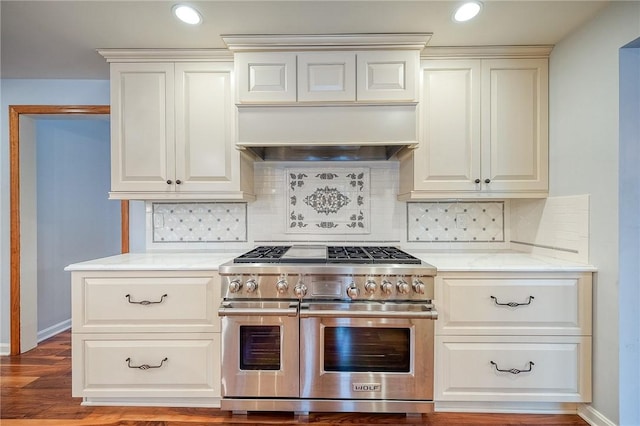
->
[549, 2, 640, 424]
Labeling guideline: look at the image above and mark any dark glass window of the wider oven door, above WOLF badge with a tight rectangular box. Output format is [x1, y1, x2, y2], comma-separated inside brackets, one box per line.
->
[324, 327, 411, 373]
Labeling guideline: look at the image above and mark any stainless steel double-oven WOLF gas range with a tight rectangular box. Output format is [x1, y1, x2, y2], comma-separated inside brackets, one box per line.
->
[218, 246, 438, 413]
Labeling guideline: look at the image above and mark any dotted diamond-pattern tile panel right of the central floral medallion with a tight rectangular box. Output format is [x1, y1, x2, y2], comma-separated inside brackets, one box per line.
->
[407, 201, 505, 243]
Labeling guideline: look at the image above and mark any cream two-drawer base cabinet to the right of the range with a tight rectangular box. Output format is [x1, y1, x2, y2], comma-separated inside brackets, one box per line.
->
[435, 272, 592, 406]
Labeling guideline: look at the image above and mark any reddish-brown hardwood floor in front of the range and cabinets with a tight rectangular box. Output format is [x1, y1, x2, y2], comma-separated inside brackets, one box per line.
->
[0, 331, 587, 426]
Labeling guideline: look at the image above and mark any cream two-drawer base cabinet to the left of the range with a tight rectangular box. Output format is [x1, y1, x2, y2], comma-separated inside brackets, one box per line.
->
[71, 271, 221, 407]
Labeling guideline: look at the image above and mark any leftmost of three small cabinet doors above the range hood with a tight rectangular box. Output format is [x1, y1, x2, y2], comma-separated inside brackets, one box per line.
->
[235, 52, 296, 102]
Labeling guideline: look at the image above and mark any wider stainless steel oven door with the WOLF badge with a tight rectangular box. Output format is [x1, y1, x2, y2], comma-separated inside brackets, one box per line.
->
[300, 302, 437, 401]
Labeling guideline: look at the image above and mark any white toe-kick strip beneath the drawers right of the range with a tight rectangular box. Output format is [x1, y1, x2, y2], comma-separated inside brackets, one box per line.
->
[434, 401, 578, 414]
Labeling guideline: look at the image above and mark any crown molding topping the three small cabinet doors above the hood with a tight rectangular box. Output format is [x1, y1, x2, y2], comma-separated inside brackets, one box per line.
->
[221, 33, 432, 52]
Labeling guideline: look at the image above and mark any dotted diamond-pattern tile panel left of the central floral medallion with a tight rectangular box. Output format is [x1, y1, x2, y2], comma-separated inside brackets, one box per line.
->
[152, 203, 247, 243]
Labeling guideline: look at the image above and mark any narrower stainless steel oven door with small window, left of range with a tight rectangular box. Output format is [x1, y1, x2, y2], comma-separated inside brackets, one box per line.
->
[218, 301, 300, 398]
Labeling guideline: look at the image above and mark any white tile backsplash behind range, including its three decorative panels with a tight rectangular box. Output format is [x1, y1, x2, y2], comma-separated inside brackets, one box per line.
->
[146, 161, 510, 250]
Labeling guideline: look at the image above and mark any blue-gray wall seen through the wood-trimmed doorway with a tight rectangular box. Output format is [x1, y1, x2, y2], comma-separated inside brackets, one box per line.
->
[36, 117, 121, 339]
